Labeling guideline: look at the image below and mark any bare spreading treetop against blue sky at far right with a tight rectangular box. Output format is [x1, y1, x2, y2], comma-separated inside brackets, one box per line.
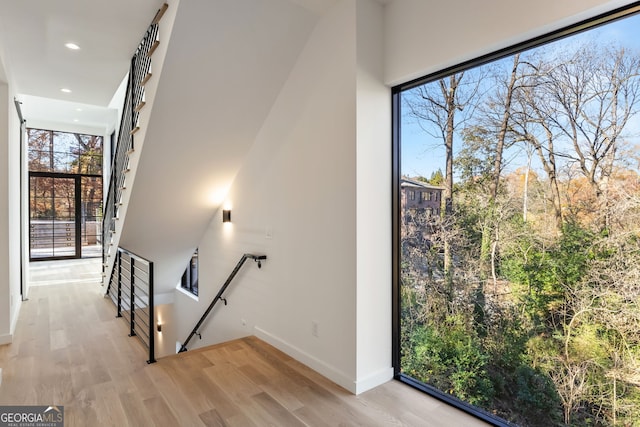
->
[541, 44, 640, 232]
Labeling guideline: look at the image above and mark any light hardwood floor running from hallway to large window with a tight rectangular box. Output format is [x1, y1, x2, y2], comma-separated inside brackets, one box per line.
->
[0, 260, 486, 427]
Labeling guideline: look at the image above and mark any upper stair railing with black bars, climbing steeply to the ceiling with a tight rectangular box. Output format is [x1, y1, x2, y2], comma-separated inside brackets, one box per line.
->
[102, 3, 168, 282]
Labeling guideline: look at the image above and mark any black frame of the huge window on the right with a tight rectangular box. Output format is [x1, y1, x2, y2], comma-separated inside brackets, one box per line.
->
[391, 1, 640, 427]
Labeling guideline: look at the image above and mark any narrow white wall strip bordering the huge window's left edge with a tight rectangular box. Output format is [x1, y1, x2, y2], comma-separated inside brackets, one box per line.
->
[355, 0, 393, 393]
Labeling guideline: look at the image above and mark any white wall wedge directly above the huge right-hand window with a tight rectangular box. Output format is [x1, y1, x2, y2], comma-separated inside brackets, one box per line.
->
[385, 0, 632, 85]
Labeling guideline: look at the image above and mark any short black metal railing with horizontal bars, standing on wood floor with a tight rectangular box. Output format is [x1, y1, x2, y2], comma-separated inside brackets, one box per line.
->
[109, 248, 156, 363]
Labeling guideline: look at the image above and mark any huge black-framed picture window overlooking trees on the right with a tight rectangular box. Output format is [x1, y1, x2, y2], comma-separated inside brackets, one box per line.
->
[393, 7, 640, 426]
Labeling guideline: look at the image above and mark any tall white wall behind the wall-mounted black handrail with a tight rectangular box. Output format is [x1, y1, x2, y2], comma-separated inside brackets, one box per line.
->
[175, 1, 357, 391]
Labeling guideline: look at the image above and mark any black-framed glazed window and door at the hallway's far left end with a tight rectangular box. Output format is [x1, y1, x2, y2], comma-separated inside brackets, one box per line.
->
[27, 129, 102, 260]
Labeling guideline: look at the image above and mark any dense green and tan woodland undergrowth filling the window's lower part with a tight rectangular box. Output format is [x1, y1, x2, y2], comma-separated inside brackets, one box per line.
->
[401, 159, 640, 427]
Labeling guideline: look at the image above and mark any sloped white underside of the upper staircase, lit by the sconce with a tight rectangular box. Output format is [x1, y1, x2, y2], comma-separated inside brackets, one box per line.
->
[121, 0, 316, 298]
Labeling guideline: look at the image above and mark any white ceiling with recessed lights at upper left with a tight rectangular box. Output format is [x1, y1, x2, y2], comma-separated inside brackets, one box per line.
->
[0, 0, 168, 127]
